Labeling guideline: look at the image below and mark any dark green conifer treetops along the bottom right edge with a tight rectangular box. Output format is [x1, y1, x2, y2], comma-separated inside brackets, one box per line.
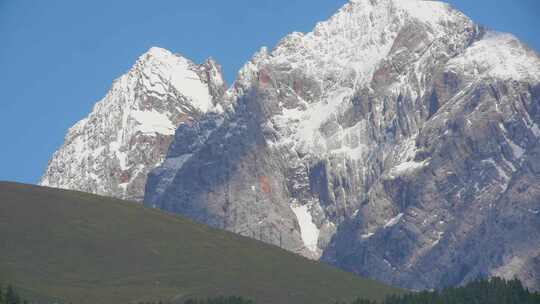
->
[340, 278, 540, 304]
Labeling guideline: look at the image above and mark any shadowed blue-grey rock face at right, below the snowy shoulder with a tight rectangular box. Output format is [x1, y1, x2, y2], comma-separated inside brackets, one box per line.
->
[323, 81, 540, 289]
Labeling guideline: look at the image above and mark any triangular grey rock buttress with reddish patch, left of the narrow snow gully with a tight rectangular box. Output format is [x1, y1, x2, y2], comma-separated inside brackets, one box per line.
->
[145, 86, 318, 257]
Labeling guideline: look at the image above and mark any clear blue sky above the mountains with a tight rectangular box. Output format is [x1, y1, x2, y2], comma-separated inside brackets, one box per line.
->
[0, 0, 540, 183]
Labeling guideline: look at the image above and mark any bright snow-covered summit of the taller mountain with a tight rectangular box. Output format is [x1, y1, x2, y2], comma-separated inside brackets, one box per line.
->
[272, 0, 472, 81]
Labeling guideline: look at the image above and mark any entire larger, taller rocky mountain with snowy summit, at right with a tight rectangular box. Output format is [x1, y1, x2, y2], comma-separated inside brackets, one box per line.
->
[145, 0, 540, 288]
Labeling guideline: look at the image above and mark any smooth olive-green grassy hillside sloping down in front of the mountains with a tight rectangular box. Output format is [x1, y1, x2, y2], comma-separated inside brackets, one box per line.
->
[0, 182, 399, 304]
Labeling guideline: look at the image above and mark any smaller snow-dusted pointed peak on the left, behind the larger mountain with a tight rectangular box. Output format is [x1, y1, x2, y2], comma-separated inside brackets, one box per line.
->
[40, 48, 225, 201]
